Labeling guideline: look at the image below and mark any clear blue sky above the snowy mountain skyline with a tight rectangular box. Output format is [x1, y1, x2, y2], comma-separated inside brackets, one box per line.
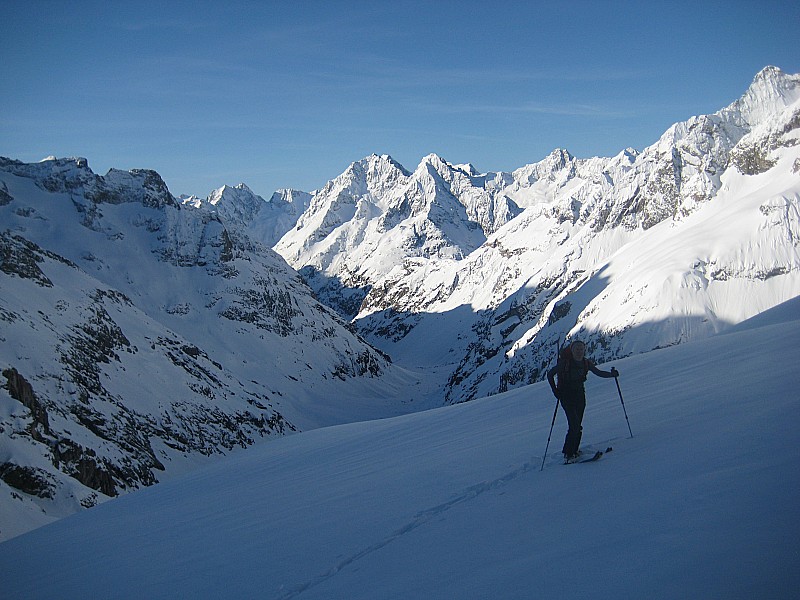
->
[0, 0, 800, 198]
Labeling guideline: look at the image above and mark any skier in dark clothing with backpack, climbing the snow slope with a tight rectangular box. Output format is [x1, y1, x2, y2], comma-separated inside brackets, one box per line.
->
[547, 341, 619, 462]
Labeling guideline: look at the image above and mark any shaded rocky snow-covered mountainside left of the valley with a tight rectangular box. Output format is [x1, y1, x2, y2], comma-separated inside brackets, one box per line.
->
[0, 159, 407, 538]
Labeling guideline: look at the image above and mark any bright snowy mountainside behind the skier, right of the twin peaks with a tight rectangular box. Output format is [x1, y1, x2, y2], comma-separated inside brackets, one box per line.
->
[346, 68, 800, 402]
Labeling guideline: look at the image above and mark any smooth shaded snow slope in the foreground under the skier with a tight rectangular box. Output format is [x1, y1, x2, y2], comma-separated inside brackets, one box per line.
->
[0, 300, 800, 599]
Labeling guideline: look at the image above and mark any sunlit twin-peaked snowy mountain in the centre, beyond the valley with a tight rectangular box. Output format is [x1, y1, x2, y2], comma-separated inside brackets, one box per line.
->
[275, 154, 520, 318]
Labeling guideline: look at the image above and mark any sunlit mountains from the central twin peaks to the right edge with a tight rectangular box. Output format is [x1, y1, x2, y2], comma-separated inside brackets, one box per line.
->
[275, 67, 800, 402]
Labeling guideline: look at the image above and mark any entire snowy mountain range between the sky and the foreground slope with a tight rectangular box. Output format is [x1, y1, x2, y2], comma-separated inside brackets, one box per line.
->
[0, 67, 800, 537]
